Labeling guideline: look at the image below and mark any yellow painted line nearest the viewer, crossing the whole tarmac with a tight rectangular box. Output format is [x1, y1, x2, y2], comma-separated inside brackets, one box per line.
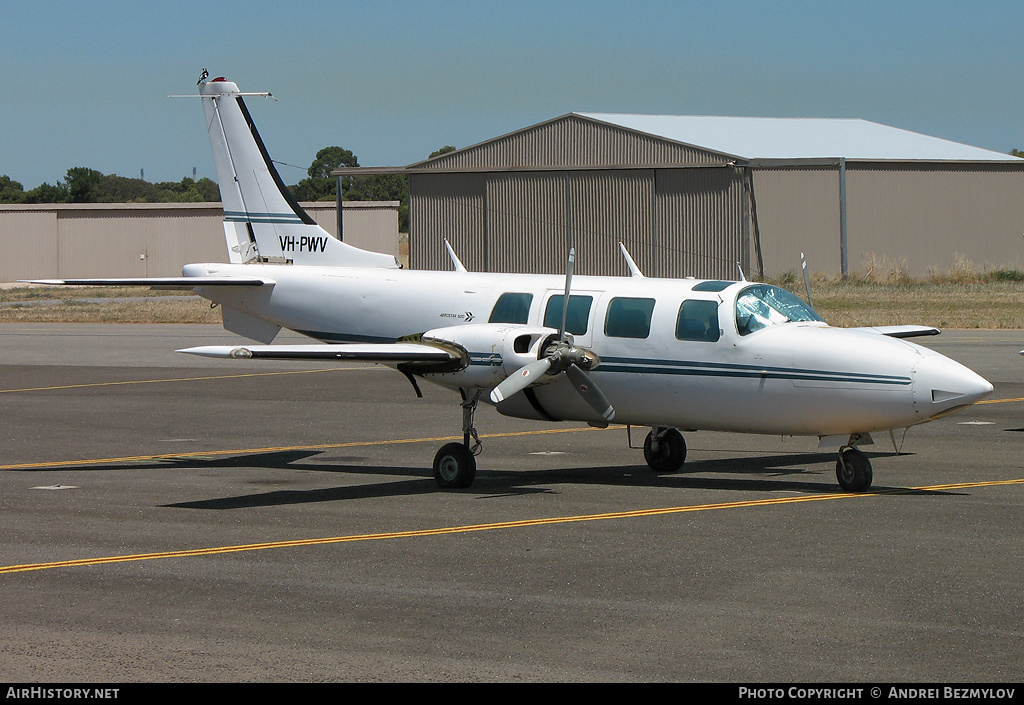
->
[0, 478, 1024, 574]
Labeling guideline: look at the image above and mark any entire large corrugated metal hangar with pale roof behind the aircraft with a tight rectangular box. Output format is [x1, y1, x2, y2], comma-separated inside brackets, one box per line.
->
[335, 113, 1024, 279]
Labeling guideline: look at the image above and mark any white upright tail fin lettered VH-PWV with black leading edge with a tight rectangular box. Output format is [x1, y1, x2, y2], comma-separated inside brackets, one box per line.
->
[199, 73, 399, 268]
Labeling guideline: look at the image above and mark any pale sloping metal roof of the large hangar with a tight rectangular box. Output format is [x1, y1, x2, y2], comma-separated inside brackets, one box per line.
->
[573, 113, 1024, 162]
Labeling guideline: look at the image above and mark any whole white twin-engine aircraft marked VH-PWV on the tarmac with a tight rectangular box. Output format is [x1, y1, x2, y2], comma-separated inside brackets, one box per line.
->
[32, 76, 992, 492]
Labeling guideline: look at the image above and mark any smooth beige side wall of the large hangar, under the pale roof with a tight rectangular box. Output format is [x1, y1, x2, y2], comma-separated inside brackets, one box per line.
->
[754, 163, 1024, 277]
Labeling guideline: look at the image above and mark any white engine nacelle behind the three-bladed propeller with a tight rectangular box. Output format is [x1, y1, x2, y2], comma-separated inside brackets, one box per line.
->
[419, 323, 558, 389]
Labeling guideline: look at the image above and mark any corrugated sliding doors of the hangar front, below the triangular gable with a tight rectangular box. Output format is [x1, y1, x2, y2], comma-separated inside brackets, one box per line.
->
[410, 167, 750, 278]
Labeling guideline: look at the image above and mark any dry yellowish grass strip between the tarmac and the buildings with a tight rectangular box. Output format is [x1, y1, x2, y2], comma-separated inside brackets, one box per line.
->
[0, 276, 1024, 329]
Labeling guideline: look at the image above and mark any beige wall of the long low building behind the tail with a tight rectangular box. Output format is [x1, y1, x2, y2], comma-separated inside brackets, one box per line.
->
[0, 201, 398, 282]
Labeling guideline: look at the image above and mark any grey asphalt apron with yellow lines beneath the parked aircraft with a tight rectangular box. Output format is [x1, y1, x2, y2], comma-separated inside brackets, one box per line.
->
[0, 324, 1024, 683]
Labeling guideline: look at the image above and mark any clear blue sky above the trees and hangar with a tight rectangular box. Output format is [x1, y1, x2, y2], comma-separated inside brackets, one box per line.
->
[0, 0, 1024, 190]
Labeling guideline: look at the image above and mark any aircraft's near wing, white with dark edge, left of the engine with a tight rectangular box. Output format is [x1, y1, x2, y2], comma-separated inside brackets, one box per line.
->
[177, 342, 460, 363]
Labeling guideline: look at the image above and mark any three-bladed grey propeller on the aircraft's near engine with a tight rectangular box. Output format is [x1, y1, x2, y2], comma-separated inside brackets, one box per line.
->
[490, 248, 615, 421]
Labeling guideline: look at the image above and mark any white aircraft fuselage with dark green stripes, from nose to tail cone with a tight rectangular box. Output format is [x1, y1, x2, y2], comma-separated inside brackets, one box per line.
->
[184, 264, 991, 437]
